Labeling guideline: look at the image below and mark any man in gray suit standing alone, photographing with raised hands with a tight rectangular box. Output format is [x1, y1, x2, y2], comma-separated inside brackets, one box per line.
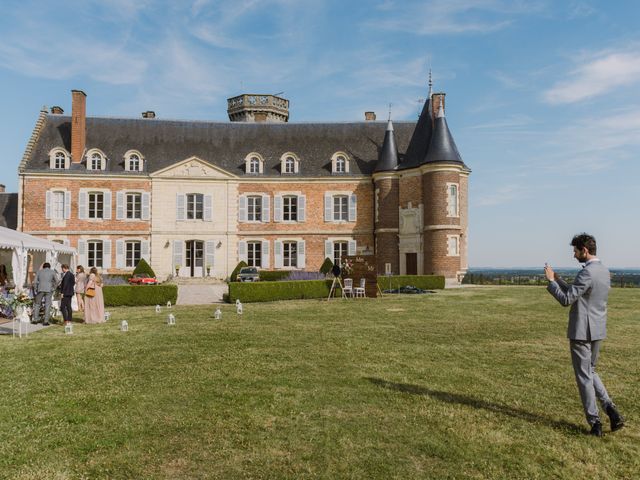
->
[544, 233, 624, 437]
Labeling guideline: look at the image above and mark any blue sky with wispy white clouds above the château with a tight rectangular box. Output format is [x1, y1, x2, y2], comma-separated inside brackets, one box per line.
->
[0, 0, 640, 267]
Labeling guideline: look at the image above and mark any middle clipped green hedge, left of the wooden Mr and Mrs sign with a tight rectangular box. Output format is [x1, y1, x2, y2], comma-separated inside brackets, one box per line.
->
[229, 280, 331, 303]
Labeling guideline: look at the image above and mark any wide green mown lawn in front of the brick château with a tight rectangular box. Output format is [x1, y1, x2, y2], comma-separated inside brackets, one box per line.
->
[0, 287, 640, 479]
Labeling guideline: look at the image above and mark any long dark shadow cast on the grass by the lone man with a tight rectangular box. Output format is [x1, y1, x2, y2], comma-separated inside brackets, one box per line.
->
[365, 377, 585, 434]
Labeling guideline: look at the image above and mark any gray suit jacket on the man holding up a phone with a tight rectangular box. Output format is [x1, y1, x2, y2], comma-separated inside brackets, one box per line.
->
[547, 260, 611, 340]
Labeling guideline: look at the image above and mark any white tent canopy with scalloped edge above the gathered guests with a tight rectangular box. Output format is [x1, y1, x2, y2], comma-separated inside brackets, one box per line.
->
[0, 227, 76, 292]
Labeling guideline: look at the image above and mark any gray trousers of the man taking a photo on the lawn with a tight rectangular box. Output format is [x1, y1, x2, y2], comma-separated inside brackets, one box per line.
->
[569, 340, 613, 425]
